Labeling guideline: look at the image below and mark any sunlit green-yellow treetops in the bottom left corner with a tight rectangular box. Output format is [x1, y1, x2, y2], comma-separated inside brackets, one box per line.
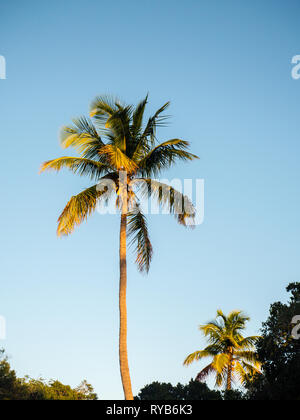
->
[0, 350, 97, 401]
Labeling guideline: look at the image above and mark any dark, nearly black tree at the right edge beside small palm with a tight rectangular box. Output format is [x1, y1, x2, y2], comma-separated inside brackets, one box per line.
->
[248, 283, 300, 400]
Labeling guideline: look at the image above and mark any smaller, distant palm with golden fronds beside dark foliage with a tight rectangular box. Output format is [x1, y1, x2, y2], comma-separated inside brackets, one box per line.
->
[184, 310, 260, 390]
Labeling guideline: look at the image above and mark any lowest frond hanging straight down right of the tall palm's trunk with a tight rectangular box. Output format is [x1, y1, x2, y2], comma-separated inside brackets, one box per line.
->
[127, 205, 153, 272]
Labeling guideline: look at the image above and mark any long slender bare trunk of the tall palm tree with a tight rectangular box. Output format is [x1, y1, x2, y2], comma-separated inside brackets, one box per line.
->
[119, 212, 133, 400]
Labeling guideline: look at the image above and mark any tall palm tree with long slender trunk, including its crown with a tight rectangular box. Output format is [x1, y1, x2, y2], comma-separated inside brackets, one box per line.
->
[41, 96, 197, 400]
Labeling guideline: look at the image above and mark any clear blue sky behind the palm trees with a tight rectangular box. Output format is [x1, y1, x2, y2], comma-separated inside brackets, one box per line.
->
[0, 0, 300, 399]
